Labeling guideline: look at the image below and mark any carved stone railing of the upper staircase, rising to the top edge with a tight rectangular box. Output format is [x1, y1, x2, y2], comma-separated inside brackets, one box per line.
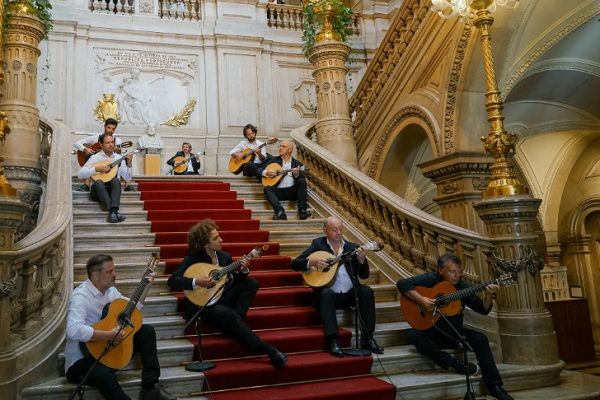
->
[350, 0, 431, 131]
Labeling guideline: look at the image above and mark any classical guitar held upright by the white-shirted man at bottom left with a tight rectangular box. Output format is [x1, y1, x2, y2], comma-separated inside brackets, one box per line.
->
[81, 253, 159, 369]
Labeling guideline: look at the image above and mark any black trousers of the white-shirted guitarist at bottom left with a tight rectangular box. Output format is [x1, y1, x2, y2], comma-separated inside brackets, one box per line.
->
[66, 325, 160, 400]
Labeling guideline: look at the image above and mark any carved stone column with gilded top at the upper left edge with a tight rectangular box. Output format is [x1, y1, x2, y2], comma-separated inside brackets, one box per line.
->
[0, 2, 45, 225]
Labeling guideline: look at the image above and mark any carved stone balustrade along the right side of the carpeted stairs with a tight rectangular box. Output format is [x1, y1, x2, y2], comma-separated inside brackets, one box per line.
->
[291, 126, 492, 282]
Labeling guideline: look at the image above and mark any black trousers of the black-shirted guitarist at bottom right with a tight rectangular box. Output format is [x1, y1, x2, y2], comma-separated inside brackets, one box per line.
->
[408, 322, 502, 388]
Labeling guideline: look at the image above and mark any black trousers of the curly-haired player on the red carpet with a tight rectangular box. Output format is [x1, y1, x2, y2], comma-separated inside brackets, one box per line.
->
[186, 278, 272, 352]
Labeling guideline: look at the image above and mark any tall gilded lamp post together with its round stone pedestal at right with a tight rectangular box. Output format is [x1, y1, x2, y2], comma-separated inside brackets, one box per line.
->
[474, 8, 559, 364]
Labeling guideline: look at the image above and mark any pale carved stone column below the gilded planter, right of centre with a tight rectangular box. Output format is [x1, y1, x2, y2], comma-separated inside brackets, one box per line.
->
[309, 40, 358, 167]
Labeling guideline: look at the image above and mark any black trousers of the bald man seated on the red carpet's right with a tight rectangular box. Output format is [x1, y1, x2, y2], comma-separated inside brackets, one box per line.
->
[317, 285, 375, 342]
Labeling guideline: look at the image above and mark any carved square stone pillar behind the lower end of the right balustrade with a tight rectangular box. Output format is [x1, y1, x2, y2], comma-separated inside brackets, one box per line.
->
[419, 152, 493, 234]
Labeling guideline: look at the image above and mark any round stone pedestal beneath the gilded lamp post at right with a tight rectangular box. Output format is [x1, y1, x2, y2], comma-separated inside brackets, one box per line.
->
[474, 195, 558, 365]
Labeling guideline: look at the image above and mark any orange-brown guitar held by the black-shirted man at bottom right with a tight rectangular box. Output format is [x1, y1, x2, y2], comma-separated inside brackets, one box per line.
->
[400, 273, 517, 331]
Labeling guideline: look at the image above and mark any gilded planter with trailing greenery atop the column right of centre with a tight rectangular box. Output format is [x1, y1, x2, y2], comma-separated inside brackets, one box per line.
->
[302, 0, 352, 56]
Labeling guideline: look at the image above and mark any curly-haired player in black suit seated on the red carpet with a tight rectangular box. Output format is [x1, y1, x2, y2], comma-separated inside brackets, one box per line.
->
[167, 219, 287, 366]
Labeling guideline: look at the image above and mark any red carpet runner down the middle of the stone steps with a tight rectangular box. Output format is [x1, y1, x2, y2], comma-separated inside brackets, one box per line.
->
[138, 181, 395, 400]
